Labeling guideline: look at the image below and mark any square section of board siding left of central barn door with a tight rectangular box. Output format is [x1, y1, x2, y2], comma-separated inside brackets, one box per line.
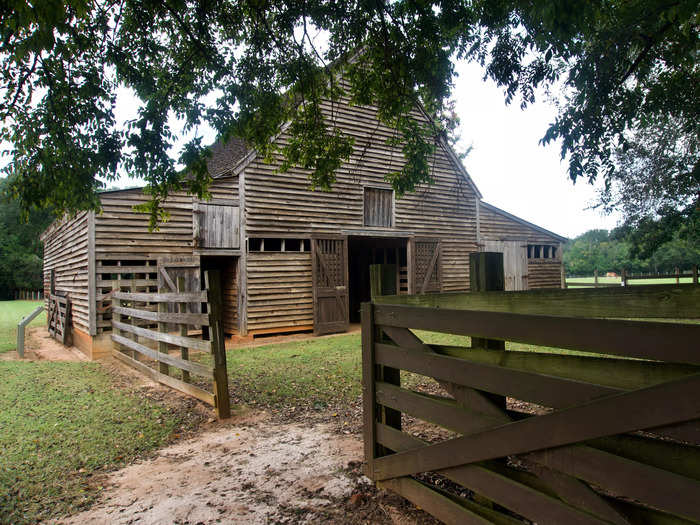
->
[248, 252, 314, 331]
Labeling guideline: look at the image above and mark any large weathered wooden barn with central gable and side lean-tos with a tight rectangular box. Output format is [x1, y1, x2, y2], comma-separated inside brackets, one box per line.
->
[42, 86, 566, 358]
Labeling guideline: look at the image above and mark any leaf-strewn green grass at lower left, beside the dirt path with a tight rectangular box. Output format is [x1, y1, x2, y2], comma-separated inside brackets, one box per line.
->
[0, 361, 179, 523]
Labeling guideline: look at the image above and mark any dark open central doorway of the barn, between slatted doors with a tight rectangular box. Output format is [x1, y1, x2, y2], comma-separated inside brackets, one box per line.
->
[348, 237, 408, 323]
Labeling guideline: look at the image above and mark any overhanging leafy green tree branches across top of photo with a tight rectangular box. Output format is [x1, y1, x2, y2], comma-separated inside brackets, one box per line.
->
[0, 0, 700, 228]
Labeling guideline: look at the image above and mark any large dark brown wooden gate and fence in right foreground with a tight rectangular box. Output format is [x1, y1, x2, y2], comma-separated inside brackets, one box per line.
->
[362, 285, 700, 524]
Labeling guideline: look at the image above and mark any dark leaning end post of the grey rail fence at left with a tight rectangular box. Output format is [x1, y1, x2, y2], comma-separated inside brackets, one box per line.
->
[204, 270, 231, 419]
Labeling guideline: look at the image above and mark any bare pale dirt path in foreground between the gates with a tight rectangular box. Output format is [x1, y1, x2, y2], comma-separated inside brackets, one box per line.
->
[56, 413, 436, 524]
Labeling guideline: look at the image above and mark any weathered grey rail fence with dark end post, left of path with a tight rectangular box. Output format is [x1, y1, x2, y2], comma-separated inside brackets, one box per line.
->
[111, 271, 230, 418]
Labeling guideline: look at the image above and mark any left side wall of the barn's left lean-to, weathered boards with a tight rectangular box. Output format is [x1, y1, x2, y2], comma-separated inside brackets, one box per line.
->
[42, 212, 90, 332]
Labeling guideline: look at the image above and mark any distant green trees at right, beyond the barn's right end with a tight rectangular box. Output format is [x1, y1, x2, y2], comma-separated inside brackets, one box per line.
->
[564, 230, 700, 276]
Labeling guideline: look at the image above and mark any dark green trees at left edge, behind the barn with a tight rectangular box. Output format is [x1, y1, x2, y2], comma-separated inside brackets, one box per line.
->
[0, 179, 53, 299]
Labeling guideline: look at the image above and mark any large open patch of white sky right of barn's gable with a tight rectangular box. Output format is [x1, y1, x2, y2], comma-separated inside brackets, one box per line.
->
[454, 59, 617, 237]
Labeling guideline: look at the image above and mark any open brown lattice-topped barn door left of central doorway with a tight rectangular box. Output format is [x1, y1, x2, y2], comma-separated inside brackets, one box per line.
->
[311, 236, 349, 335]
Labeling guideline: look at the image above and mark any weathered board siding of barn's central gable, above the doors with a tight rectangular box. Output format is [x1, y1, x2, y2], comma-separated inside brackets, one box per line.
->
[245, 90, 477, 290]
